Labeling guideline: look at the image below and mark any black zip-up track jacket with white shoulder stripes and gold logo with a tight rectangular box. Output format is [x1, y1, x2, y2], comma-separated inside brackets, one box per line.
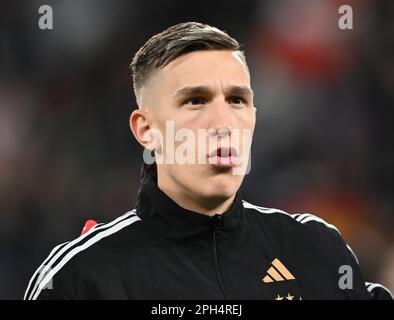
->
[24, 168, 392, 300]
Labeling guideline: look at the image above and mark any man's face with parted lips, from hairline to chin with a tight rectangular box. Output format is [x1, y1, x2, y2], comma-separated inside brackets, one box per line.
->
[141, 51, 256, 205]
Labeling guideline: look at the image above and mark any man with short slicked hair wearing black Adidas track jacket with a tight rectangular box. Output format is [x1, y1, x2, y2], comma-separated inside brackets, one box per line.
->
[25, 22, 391, 300]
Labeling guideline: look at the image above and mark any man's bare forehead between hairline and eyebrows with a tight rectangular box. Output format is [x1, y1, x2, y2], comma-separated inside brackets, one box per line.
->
[159, 50, 250, 91]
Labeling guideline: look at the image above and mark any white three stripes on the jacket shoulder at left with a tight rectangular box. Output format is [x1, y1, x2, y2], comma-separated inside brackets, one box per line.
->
[23, 209, 141, 300]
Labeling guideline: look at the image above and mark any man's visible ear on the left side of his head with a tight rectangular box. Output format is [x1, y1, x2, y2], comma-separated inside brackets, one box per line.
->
[129, 109, 154, 150]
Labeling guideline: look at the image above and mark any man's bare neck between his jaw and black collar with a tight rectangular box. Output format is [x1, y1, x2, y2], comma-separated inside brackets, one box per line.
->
[157, 169, 235, 216]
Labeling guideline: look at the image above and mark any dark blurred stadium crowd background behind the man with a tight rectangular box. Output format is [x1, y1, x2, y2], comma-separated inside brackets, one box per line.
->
[0, 0, 394, 299]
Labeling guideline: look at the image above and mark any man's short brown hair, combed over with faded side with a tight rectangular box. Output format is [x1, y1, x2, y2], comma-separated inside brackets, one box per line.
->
[130, 22, 245, 106]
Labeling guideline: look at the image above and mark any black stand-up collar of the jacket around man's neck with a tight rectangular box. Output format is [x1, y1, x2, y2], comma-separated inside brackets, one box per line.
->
[136, 164, 245, 248]
